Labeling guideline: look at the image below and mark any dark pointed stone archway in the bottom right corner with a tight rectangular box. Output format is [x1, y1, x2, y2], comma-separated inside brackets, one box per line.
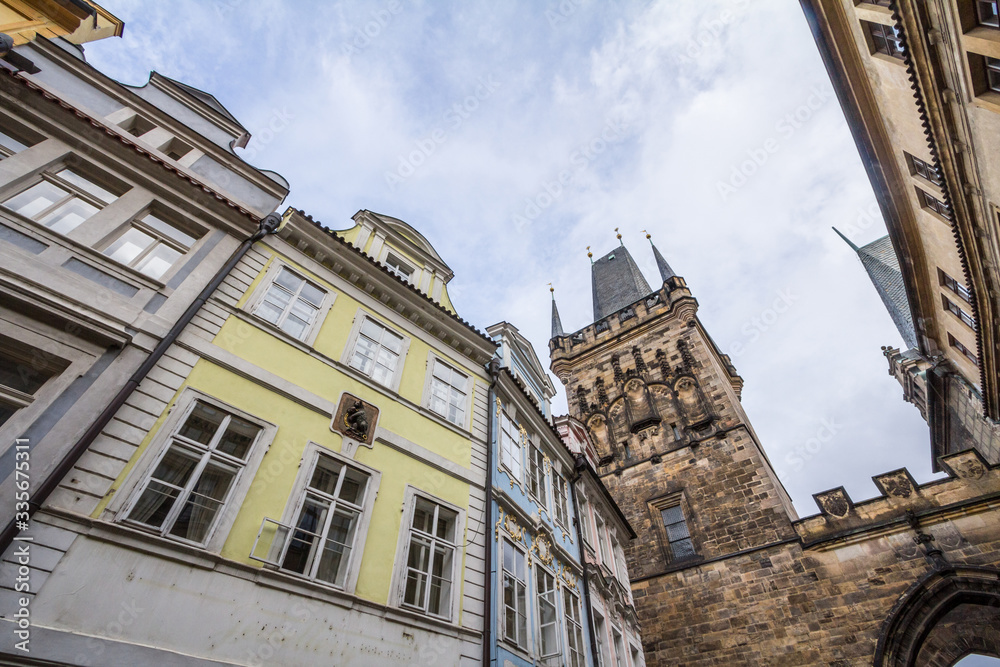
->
[874, 567, 1000, 667]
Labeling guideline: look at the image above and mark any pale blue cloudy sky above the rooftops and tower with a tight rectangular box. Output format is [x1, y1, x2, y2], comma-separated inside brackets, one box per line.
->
[87, 0, 932, 516]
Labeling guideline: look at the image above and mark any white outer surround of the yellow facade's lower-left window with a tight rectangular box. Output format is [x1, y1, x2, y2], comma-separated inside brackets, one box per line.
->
[114, 388, 277, 552]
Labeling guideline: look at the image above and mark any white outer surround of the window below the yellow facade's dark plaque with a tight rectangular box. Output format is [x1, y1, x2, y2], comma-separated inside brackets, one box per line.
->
[251, 441, 382, 594]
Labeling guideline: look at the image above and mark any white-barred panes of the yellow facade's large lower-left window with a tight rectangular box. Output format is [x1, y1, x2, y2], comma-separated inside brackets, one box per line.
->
[127, 401, 261, 544]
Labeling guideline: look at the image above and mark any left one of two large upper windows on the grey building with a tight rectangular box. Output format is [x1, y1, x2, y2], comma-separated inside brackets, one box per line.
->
[3, 167, 122, 234]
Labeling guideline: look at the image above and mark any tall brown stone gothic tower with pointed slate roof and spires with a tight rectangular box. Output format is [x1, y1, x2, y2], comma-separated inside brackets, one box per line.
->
[549, 236, 796, 616]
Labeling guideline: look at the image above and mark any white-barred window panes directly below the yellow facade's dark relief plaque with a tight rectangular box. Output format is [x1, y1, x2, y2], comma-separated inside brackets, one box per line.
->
[281, 454, 368, 587]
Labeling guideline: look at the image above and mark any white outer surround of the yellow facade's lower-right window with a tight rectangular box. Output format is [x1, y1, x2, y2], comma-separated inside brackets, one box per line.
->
[390, 484, 466, 625]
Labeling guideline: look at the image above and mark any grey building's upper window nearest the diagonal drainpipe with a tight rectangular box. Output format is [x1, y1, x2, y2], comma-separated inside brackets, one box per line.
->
[104, 213, 196, 280]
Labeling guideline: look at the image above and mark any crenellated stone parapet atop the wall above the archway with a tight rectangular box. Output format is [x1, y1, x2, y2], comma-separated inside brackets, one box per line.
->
[794, 449, 1000, 549]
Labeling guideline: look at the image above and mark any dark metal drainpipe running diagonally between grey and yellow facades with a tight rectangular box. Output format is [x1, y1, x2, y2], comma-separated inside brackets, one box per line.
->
[0, 213, 281, 554]
